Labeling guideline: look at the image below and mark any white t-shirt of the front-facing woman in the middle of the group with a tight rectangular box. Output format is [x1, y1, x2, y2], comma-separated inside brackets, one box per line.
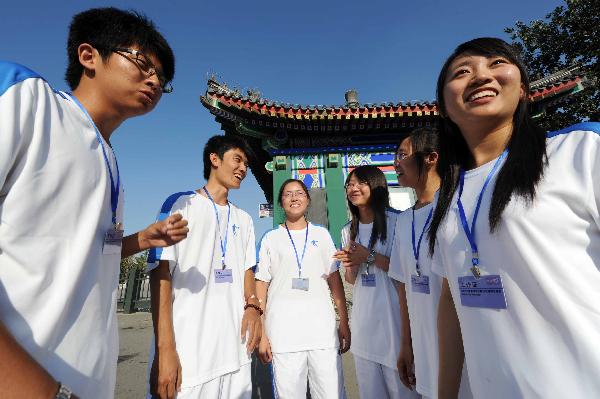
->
[256, 223, 338, 353]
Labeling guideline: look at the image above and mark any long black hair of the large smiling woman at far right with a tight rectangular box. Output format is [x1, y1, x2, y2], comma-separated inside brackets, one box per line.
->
[429, 37, 547, 254]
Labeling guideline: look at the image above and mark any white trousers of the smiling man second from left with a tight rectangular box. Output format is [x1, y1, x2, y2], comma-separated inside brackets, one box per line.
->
[177, 363, 252, 399]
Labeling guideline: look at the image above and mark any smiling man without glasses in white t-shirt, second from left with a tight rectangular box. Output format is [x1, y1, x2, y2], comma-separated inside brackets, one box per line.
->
[148, 136, 262, 399]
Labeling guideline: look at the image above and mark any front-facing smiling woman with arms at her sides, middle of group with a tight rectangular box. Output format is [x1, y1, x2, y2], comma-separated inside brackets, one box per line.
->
[256, 179, 350, 399]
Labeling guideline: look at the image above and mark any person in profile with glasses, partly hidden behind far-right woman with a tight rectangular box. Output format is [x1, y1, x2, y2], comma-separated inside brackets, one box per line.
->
[388, 127, 472, 399]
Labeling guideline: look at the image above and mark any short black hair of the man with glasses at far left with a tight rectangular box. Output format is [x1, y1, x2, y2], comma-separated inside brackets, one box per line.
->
[65, 7, 175, 90]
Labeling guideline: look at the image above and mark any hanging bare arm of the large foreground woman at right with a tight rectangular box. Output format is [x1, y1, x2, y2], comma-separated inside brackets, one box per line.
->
[438, 279, 465, 399]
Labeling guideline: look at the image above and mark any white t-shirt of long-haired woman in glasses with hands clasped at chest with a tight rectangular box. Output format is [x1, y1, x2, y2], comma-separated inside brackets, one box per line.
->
[342, 209, 401, 369]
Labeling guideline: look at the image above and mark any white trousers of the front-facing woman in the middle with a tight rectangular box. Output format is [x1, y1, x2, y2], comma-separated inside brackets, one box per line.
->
[273, 348, 346, 399]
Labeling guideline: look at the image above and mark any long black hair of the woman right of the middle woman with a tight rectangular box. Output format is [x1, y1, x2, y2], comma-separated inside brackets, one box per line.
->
[344, 165, 390, 248]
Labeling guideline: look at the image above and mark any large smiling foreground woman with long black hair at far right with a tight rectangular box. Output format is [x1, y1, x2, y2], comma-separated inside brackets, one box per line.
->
[429, 38, 600, 398]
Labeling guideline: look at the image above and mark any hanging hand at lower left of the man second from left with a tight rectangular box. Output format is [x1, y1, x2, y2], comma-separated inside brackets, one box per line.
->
[150, 349, 181, 399]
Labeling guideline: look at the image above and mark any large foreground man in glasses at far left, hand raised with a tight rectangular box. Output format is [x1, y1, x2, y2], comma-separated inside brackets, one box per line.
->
[0, 8, 188, 399]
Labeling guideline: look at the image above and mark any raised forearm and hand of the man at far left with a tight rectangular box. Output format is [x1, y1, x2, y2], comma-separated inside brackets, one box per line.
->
[121, 213, 189, 258]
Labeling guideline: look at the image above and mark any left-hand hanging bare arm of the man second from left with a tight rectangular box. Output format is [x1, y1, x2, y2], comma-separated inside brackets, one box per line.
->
[150, 260, 181, 398]
